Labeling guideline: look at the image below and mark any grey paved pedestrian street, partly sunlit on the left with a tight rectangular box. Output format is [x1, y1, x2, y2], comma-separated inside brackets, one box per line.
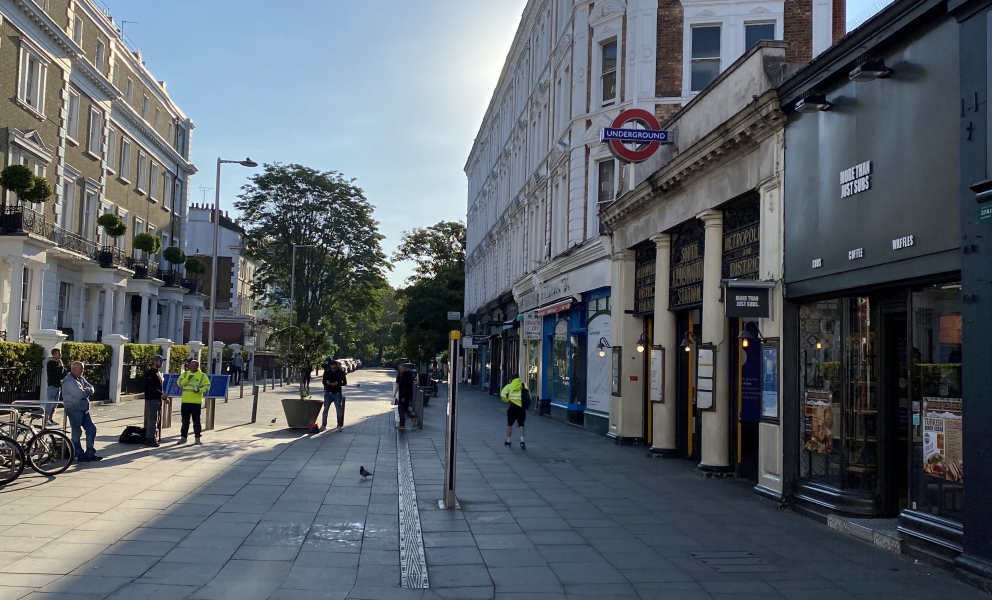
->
[0, 369, 988, 600]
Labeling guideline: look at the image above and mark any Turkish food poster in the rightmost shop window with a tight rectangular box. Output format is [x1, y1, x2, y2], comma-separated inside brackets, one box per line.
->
[923, 398, 964, 481]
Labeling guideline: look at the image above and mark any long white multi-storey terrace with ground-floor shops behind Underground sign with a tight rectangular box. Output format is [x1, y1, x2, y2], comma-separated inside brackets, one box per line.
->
[465, 0, 844, 433]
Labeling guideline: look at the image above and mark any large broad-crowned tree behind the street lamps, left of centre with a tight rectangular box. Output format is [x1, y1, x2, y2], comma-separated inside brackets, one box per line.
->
[235, 164, 391, 330]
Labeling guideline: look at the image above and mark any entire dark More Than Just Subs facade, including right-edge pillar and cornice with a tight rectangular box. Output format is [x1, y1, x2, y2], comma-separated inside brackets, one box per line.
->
[779, 0, 992, 587]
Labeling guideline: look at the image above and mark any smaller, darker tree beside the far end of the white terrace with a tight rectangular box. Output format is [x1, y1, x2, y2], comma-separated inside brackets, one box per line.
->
[393, 221, 465, 362]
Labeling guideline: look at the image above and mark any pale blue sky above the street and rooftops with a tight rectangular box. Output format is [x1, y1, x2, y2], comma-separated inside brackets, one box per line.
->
[112, 0, 888, 286]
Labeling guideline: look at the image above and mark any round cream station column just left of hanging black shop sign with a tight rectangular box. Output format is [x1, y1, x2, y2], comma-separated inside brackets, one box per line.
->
[696, 210, 731, 474]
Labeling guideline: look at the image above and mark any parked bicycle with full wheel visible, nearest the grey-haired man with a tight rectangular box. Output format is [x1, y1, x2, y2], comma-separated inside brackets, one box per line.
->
[0, 400, 76, 477]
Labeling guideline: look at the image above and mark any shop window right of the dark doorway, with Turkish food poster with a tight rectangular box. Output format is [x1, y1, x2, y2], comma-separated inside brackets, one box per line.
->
[910, 284, 964, 521]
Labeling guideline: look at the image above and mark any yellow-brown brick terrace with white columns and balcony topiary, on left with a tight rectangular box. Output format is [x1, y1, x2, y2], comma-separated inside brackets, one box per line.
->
[0, 0, 203, 342]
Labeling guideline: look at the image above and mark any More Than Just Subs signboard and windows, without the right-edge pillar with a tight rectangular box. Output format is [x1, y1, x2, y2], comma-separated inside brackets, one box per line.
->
[782, 11, 969, 561]
